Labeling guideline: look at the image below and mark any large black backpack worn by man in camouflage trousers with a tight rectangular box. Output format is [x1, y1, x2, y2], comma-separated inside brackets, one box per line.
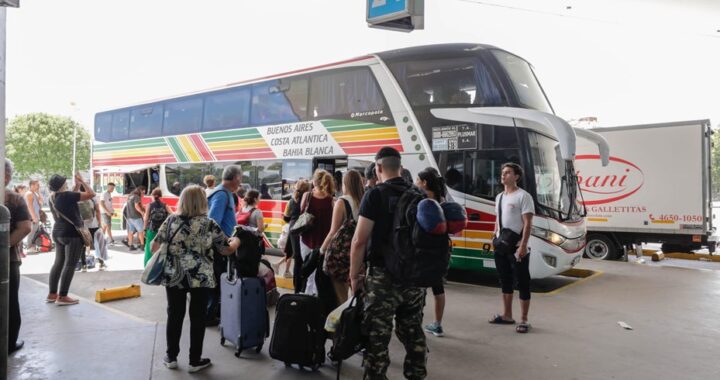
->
[381, 184, 450, 288]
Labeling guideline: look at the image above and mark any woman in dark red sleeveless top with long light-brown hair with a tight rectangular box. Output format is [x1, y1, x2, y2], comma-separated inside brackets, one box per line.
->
[300, 169, 335, 295]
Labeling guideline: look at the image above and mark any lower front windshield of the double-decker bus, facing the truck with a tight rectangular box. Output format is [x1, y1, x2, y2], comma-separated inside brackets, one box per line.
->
[528, 132, 583, 221]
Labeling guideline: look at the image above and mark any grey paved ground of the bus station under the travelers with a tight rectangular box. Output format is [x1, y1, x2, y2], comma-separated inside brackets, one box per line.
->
[10, 242, 720, 380]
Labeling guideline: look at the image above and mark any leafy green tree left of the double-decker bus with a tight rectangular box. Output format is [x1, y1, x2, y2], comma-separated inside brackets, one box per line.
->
[6, 113, 90, 180]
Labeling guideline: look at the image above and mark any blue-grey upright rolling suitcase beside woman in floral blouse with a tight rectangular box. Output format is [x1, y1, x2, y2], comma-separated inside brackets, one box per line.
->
[220, 262, 270, 357]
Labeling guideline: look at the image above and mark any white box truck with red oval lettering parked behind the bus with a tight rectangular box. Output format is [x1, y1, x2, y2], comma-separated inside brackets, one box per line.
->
[575, 120, 716, 260]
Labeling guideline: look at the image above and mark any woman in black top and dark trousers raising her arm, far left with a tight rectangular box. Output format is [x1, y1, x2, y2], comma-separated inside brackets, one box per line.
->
[45, 174, 95, 306]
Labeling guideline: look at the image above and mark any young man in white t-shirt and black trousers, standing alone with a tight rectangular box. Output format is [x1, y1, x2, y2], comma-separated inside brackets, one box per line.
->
[489, 163, 535, 333]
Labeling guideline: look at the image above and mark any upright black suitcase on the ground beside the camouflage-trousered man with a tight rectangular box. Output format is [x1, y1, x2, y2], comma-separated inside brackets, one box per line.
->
[270, 294, 325, 371]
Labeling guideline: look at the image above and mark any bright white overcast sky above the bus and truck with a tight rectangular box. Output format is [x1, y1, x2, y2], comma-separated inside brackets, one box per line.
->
[6, 0, 720, 129]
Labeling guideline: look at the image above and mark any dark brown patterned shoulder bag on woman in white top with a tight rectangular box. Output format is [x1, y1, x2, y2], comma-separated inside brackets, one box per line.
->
[323, 199, 357, 282]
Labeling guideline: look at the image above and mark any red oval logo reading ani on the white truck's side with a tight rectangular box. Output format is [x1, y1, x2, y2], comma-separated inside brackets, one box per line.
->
[575, 154, 645, 206]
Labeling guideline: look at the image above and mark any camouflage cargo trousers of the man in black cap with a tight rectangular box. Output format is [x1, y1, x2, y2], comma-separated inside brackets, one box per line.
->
[363, 268, 427, 380]
